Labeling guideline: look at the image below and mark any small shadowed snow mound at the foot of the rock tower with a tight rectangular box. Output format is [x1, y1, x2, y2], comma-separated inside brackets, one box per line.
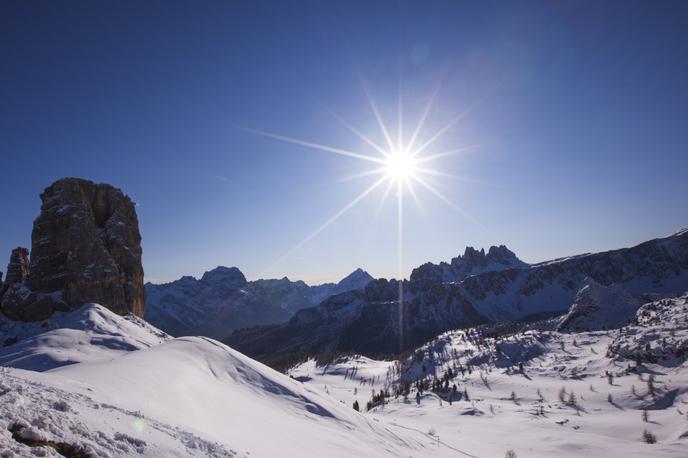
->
[0, 304, 170, 371]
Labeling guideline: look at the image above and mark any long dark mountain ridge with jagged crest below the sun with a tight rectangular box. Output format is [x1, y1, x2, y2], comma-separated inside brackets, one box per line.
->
[226, 230, 688, 365]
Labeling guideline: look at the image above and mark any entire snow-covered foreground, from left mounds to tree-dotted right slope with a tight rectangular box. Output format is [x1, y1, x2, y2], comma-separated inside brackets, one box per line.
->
[0, 296, 688, 458]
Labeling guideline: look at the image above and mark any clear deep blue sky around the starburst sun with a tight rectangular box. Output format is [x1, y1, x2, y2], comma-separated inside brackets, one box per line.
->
[0, 1, 688, 282]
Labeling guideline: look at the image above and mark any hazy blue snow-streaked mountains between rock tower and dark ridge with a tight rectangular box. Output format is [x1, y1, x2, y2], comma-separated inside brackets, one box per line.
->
[145, 266, 373, 338]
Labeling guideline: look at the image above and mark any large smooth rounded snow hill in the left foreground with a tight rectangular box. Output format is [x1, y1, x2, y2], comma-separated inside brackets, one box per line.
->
[0, 337, 432, 457]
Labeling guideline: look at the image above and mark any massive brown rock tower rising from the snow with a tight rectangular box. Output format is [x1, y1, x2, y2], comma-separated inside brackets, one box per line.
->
[2, 178, 146, 321]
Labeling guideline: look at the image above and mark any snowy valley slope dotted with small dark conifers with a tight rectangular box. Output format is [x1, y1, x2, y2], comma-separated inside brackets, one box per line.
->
[289, 306, 688, 458]
